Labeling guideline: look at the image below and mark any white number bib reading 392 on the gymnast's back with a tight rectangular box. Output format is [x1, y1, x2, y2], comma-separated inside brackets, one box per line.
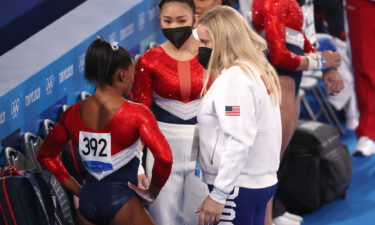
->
[79, 131, 113, 173]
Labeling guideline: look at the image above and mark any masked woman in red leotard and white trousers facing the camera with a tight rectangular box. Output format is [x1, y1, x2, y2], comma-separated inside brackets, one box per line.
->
[132, 0, 208, 225]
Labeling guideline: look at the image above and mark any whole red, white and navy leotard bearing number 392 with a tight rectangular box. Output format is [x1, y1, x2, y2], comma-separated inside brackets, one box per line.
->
[38, 100, 172, 224]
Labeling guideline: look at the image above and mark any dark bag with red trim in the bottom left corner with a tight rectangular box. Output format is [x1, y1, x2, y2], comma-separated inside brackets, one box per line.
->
[0, 167, 74, 225]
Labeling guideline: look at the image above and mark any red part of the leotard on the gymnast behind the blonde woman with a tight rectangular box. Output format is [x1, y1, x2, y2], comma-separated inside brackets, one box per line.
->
[252, 0, 316, 71]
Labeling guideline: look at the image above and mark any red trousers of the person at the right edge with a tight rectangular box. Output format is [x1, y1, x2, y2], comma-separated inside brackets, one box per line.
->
[346, 0, 375, 140]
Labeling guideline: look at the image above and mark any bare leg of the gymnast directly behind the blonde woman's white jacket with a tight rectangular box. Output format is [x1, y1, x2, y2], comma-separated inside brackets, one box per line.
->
[264, 76, 300, 225]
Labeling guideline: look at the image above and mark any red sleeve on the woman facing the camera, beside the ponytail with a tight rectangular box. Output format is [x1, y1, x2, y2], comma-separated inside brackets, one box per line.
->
[132, 53, 152, 108]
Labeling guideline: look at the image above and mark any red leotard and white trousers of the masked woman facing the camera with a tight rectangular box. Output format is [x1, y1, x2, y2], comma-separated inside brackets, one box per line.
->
[132, 46, 208, 225]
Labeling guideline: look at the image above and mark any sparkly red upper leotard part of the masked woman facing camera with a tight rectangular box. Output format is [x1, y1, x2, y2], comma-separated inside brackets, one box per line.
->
[132, 46, 205, 107]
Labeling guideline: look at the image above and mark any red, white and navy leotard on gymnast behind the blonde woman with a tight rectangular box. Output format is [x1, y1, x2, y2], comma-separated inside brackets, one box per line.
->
[251, 0, 316, 90]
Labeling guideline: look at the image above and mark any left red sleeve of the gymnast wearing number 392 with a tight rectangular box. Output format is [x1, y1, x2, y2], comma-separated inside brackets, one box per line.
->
[37, 110, 70, 184]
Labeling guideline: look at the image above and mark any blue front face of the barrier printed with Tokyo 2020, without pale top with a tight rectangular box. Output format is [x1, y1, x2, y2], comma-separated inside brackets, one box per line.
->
[0, 0, 164, 163]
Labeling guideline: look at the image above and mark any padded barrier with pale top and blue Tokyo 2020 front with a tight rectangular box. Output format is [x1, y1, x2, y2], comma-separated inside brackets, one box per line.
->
[0, 0, 165, 162]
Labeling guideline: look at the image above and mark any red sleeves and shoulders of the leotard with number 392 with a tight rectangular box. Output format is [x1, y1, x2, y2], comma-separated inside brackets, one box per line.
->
[38, 101, 172, 187]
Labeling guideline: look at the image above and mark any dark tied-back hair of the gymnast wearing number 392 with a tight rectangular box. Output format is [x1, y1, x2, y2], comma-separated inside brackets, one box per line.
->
[84, 38, 133, 86]
